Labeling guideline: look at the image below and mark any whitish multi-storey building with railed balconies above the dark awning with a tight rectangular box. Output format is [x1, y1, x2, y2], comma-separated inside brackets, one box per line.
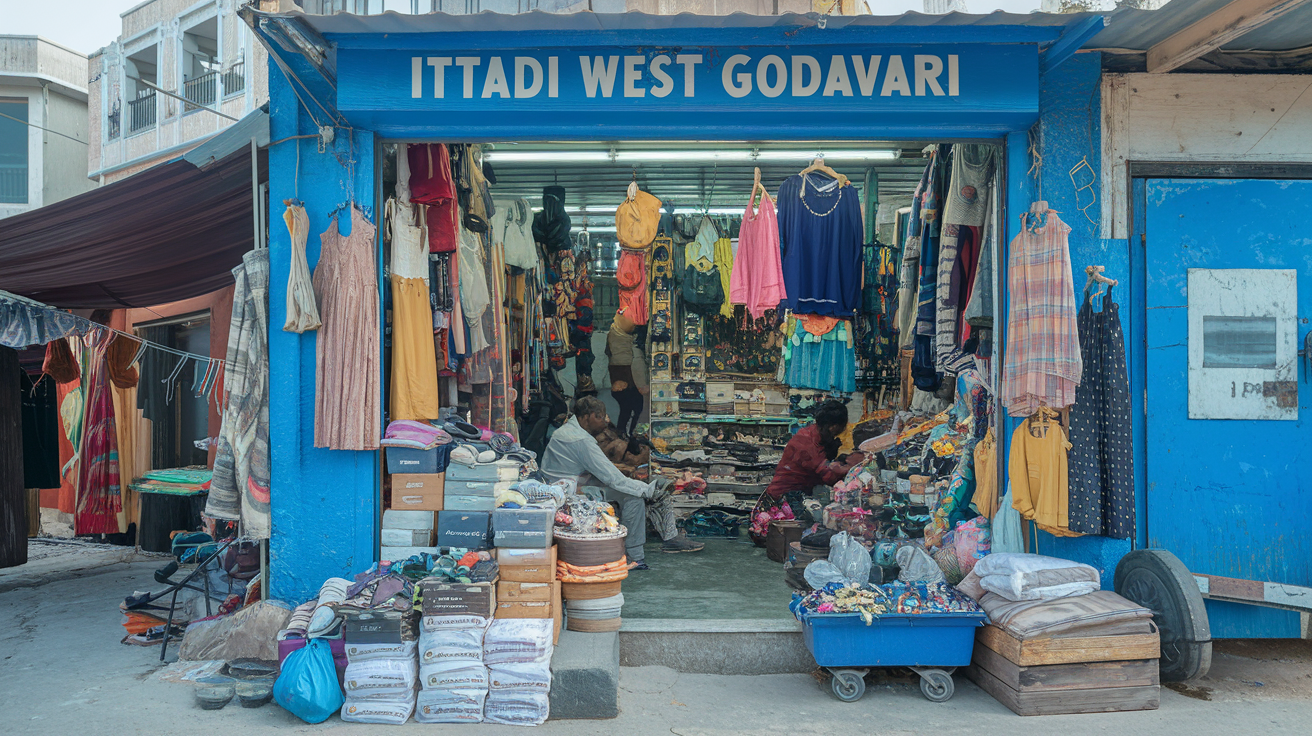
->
[87, 0, 269, 184]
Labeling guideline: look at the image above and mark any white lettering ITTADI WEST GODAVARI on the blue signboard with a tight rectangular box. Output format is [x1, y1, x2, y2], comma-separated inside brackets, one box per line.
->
[411, 54, 960, 100]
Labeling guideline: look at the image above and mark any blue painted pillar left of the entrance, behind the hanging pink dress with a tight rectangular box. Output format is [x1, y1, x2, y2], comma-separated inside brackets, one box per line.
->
[269, 64, 382, 603]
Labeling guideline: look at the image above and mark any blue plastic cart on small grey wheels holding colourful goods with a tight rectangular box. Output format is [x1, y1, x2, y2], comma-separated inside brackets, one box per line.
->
[802, 613, 988, 703]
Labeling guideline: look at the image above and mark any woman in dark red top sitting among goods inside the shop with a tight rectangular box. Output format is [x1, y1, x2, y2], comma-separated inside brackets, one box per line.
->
[752, 400, 863, 544]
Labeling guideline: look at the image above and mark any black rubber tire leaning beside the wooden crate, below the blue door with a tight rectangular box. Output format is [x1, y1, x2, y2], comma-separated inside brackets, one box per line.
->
[1114, 550, 1212, 682]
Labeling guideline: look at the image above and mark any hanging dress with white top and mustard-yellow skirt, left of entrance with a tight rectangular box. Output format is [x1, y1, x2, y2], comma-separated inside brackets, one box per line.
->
[386, 199, 438, 421]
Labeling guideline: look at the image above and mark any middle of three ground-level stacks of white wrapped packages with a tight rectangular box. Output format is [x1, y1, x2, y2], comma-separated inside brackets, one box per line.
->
[415, 614, 488, 723]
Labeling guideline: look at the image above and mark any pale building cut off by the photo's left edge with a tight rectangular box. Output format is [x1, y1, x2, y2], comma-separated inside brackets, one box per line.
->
[0, 35, 92, 218]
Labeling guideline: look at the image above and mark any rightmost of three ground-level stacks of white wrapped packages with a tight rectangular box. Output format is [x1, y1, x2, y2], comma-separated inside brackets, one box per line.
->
[483, 618, 554, 726]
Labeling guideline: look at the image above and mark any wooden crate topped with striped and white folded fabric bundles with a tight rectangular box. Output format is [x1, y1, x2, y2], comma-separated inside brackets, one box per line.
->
[958, 554, 1161, 715]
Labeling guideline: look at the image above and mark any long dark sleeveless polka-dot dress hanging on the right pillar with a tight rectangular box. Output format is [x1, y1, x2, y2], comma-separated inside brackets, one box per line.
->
[1069, 282, 1135, 539]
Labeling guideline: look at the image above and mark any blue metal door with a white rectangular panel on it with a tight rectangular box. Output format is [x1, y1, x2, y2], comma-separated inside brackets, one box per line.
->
[1136, 178, 1312, 638]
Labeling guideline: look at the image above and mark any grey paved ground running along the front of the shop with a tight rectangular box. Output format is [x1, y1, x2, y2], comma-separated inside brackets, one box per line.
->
[0, 548, 1312, 736]
